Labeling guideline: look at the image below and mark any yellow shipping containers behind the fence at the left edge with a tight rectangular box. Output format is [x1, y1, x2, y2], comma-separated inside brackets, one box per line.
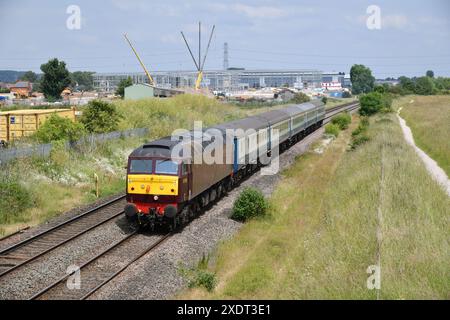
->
[0, 109, 75, 142]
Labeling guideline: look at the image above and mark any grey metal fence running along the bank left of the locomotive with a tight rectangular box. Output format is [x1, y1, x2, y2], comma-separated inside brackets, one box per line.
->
[0, 128, 148, 165]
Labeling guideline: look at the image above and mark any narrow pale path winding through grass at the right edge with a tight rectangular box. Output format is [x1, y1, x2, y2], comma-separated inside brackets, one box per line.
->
[397, 108, 450, 197]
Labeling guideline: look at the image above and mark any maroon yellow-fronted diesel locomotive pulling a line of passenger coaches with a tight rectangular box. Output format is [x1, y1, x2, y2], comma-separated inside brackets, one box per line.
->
[124, 100, 325, 230]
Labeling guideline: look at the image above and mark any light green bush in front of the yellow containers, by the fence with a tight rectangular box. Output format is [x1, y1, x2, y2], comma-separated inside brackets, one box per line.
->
[35, 114, 85, 143]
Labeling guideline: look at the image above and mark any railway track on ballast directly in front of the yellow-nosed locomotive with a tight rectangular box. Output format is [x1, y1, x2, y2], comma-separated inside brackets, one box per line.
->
[30, 231, 172, 300]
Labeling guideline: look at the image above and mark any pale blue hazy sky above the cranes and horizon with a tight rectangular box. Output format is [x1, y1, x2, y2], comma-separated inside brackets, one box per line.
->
[0, 0, 450, 78]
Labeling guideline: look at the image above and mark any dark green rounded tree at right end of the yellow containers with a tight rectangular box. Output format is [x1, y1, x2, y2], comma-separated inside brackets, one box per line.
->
[81, 100, 121, 133]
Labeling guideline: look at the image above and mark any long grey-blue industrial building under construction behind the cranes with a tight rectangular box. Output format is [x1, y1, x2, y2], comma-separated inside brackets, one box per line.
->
[93, 68, 345, 92]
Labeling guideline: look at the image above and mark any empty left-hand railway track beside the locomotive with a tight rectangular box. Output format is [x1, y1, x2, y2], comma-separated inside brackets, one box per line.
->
[0, 196, 125, 279]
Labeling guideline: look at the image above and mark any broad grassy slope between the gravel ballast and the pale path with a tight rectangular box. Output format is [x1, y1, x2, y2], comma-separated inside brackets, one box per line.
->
[181, 114, 450, 299]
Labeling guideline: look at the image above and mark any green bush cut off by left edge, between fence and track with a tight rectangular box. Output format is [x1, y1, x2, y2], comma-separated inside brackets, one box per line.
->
[0, 177, 33, 224]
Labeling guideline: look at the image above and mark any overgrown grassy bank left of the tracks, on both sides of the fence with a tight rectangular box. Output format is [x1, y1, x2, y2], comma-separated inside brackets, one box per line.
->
[0, 95, 250, 235]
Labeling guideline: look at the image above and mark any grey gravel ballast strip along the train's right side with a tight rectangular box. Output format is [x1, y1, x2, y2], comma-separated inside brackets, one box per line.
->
[88, 129, 323, 300]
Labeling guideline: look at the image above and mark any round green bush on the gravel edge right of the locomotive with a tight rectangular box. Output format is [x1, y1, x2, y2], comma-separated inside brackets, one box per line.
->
[231, 188, 268, 221]
